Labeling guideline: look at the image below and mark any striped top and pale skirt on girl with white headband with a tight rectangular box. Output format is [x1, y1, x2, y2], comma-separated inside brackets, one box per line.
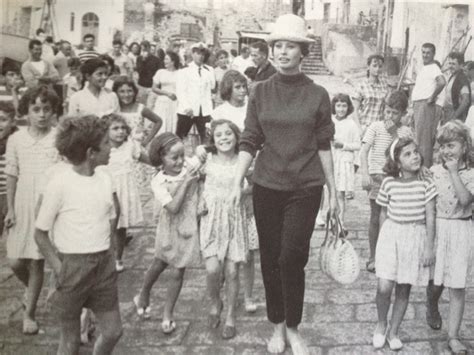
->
[375, 177, 438, 286]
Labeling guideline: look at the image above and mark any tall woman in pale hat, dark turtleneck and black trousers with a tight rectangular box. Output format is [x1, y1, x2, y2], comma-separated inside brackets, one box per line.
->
[233, 14, 338, 355]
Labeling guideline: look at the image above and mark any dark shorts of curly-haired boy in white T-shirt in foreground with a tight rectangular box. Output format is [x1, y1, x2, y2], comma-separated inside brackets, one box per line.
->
[49, 250, 118, 320]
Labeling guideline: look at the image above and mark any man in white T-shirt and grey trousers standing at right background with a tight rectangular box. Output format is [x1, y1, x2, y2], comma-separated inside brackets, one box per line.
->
[411, 43, 446, 168]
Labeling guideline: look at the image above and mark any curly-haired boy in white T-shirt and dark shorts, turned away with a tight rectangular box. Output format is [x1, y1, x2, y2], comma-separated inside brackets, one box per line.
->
[35, 115, 122, 354]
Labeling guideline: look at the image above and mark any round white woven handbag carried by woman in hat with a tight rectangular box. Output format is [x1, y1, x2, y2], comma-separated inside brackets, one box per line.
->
[321, 218, 360, 284]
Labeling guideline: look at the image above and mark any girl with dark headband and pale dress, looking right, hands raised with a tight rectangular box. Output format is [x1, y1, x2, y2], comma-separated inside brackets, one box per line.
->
[133, 132, 200, 334]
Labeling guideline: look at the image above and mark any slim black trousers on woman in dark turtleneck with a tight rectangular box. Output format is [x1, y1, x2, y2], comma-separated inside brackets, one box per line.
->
[253, 184, 323, 327]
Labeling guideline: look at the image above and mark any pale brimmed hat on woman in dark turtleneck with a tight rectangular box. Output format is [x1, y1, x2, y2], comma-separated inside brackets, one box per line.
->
[267, 14, 314, 44]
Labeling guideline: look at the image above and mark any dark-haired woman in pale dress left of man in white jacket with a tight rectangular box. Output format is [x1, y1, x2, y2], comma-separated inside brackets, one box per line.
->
[152, 51, 179, 133]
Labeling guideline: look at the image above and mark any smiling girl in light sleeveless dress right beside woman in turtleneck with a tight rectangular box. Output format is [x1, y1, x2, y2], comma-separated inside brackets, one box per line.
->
[200, 120, 252, 339]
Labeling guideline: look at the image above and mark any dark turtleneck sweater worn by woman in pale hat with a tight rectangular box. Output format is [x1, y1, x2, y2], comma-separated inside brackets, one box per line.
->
[240, 73, 334, 191]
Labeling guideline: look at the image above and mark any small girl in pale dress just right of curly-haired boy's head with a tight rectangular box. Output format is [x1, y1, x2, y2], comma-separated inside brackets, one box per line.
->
[106, 114, 149, 272]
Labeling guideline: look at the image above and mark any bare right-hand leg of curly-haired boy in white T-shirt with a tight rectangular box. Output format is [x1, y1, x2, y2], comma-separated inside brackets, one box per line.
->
[93, 308, 123, 355]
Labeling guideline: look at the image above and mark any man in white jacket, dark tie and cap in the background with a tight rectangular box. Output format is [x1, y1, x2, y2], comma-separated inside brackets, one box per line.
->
[176, 43, 216, 143]
